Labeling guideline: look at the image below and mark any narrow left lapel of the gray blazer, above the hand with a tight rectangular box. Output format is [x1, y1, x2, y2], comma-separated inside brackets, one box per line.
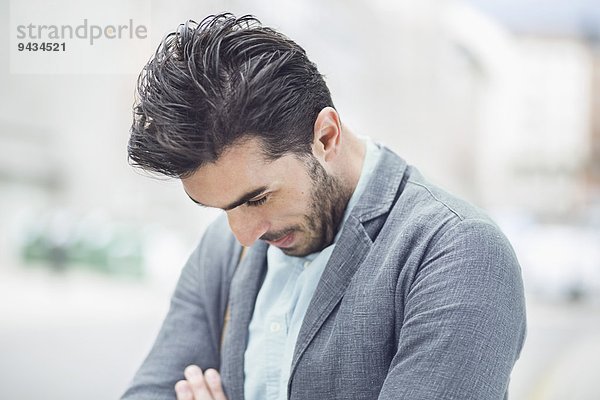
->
[221, 242, 268, 400]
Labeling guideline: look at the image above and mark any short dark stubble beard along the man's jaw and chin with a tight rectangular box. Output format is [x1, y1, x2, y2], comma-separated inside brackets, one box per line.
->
[276, 155, 353, 257]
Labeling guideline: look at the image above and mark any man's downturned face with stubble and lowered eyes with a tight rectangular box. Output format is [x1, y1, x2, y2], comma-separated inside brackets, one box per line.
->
[182, 139, 351, 256]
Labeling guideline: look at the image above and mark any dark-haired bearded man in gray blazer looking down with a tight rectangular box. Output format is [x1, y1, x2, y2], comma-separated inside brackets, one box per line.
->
[123, 14, 525, 400]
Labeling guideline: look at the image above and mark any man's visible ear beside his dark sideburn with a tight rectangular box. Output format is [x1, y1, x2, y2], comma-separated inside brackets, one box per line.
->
[313, 107, 342, 161]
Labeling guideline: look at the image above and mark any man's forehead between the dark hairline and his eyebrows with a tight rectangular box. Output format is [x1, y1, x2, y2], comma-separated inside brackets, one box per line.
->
[181, 139, 305, 208]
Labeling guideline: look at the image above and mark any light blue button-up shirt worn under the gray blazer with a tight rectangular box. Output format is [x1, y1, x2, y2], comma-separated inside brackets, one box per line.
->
[244, 137, 381, 400]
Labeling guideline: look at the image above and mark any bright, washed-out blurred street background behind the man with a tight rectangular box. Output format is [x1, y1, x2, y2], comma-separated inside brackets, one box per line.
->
[0, 0, 600, 400]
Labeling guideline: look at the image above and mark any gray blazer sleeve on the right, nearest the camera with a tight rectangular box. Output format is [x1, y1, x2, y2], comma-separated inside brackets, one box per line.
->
[379, 220, 526, 400]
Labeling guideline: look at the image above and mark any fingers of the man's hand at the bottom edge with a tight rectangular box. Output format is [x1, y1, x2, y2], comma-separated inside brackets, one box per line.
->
[175, 365, 227, 400]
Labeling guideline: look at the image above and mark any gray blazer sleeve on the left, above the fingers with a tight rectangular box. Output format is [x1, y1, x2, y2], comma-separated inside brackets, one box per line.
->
[121, 218, 241, 400]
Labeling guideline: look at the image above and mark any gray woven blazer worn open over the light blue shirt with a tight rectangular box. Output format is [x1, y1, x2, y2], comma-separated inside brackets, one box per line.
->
[123, 148, 525, 400]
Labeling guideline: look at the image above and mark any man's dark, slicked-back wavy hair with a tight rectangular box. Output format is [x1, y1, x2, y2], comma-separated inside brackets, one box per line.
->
[128, 13, 333, 177]
